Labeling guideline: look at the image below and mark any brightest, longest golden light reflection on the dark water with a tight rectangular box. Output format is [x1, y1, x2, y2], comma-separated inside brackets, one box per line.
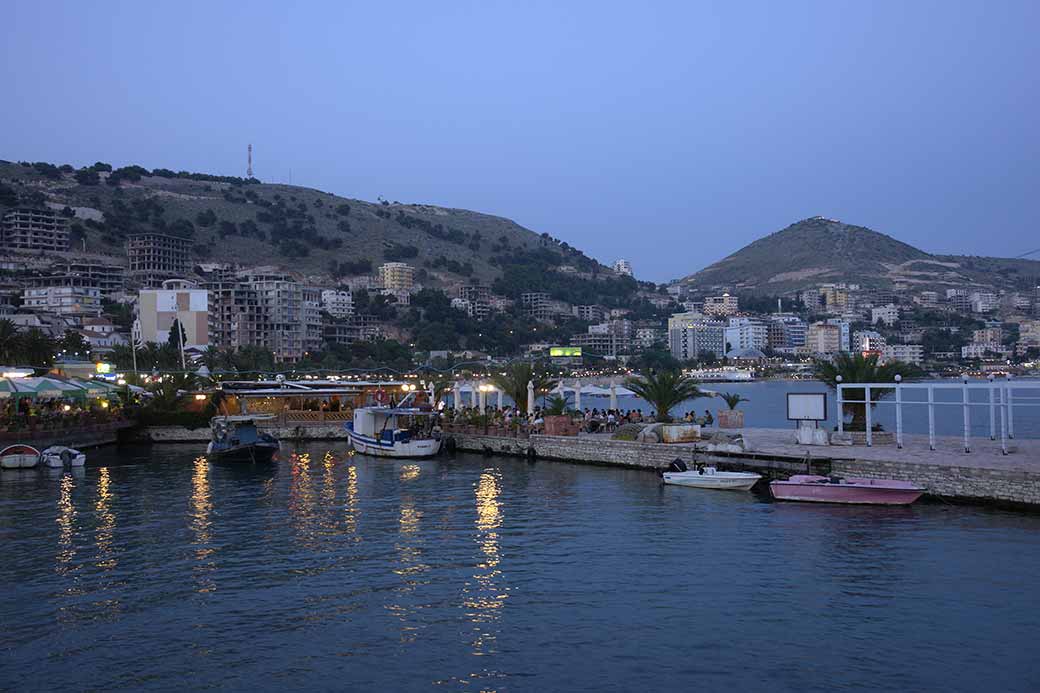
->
[464, 471, 509, 655]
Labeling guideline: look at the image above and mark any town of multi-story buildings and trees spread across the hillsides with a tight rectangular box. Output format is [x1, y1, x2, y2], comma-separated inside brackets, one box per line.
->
[0, 196, 1040, 373]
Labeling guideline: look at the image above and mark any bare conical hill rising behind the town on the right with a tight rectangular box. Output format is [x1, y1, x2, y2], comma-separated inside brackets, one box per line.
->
[677, 216, 1040, 294]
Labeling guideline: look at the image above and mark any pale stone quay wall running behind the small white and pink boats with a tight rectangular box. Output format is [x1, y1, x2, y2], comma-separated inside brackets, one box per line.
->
[451, 433, 1040, 510]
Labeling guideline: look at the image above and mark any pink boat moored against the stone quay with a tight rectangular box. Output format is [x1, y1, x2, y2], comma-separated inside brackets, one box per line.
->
[770, 474, 925, 506]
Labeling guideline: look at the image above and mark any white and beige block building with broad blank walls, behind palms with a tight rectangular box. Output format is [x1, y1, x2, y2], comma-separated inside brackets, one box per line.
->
[137, 280, 209, 349]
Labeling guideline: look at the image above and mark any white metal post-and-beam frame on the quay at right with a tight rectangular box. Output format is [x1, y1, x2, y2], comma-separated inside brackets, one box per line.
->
[836, 376, 1040, 455]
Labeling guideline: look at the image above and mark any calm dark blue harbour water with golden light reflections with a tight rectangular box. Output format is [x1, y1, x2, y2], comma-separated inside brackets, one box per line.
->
[0, 445, 1040, 691]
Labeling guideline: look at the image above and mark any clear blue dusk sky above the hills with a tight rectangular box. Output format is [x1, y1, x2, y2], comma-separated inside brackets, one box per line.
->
[0, 0, 1040, 282]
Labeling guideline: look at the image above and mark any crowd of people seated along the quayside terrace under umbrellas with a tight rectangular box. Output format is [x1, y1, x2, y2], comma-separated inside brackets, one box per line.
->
[442, 407, 714, 433]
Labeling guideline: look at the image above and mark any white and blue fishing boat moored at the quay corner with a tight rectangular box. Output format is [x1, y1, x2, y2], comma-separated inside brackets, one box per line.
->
[343, 394, 441, 458]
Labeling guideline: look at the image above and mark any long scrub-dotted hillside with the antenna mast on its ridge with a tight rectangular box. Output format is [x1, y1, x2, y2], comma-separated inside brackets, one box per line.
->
[0, 161, 614, 290]
